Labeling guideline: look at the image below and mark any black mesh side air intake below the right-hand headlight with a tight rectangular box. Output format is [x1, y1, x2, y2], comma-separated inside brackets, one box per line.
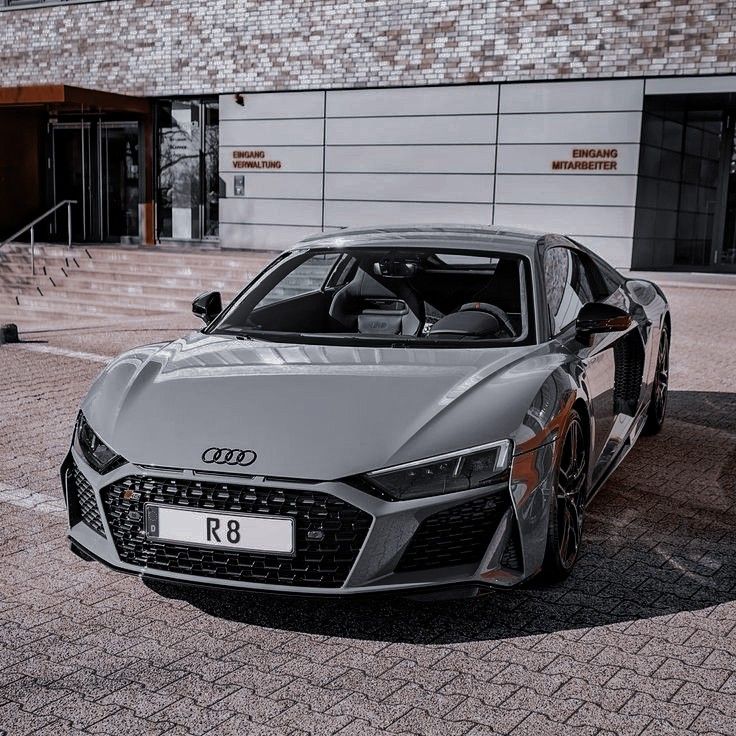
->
[396, 489, 511, 572]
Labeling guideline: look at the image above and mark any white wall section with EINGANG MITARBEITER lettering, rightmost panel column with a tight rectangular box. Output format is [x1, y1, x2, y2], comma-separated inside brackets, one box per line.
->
[494, 80, 644, 266]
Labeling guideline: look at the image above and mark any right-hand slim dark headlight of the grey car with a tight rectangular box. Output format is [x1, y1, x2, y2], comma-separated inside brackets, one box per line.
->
[364, 440, 511, 501]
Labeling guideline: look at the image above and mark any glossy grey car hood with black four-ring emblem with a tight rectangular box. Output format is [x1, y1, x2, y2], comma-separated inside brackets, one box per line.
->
[82, 333, 550, 480]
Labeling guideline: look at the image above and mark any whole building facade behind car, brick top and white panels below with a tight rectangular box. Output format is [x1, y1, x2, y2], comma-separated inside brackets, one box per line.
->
[0, 0, 736, 268]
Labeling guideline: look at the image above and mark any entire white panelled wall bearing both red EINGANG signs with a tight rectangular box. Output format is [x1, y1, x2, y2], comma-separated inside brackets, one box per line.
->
[220, 80, 643, 266]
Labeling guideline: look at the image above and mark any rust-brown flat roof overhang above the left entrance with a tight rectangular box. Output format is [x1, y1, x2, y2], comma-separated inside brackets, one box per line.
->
[0, 84, 151, 115]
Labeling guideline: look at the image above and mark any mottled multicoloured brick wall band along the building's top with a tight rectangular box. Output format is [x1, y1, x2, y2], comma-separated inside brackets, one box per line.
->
[0, 0, 736, 95]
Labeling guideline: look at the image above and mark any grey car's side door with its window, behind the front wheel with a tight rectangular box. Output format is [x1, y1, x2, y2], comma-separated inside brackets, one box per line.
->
[544, 246, 621, 482]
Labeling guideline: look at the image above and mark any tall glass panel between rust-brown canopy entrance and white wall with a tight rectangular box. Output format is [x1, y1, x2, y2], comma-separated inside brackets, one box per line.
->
[156, 100, 220, 240]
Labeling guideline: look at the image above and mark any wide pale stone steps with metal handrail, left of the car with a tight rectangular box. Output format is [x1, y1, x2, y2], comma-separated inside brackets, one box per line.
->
[0, 243, 275, 333]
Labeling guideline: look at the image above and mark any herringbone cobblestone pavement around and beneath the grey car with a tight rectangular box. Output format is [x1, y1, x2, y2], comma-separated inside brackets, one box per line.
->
[0, 288, 736, 736]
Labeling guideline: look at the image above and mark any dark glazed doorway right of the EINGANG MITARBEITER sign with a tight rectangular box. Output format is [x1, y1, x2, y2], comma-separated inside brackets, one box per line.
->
[632, 95, 736, 271]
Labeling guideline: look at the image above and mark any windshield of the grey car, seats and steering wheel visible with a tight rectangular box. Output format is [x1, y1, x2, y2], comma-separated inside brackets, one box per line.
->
[207, 246, 534, 347]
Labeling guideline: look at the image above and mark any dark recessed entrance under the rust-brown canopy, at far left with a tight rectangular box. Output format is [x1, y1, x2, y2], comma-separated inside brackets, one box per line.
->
[0, 84, 153, 243]
